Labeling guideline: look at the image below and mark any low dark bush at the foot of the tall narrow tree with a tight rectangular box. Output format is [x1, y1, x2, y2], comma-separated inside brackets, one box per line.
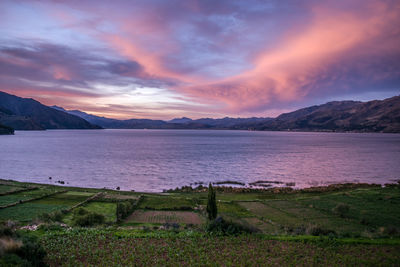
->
[206, 217, 259, 235]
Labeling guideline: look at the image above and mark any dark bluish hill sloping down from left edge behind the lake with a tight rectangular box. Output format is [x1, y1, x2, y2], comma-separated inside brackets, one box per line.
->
[0, 92, 101, 130]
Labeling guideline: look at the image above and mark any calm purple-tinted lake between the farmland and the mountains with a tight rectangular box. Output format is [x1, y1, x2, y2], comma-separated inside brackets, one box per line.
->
[0, 130, 400, 192]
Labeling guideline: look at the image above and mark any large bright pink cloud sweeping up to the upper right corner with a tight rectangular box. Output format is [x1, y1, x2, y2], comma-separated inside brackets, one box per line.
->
[176, 2, 400, 111]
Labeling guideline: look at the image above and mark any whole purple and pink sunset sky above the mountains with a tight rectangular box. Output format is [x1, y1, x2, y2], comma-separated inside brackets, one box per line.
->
[0, 0, 400, 119]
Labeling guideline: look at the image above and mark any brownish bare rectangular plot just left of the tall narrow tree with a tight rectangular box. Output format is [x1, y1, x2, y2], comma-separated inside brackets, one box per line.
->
[125, 210, 204, 224]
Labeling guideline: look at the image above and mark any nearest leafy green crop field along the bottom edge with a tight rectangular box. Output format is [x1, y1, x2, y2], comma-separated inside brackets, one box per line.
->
[41, 230, 400, 266]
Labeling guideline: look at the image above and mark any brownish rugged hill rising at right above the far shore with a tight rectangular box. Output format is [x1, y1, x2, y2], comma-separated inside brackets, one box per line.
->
[237, 96, 400, 133]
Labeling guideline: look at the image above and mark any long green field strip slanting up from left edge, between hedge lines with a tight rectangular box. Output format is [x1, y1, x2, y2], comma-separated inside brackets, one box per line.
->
[0, 190, 93, 222]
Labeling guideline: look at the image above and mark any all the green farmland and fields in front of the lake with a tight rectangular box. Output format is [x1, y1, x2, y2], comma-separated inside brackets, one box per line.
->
[0, 180, 400, 266]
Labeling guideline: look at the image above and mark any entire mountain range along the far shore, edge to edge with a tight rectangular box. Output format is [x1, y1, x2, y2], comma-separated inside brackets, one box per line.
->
[0, 92, 400, 133]
